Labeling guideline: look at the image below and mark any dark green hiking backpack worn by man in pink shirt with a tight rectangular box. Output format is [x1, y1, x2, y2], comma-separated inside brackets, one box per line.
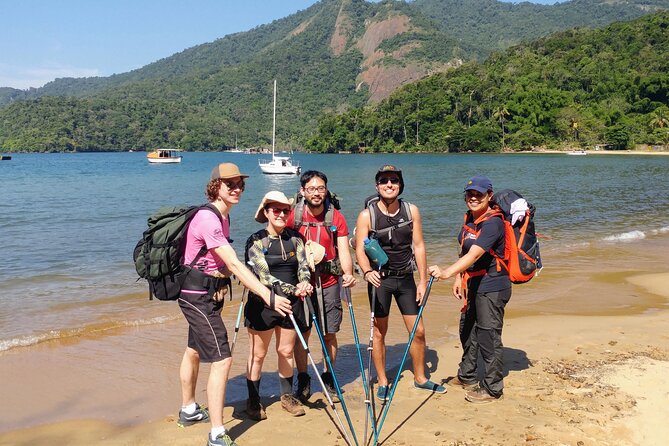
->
[133, 204, 230, 300]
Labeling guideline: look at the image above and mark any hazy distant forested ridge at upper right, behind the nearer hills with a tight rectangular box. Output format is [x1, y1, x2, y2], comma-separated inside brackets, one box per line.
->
[413, 0, 669, 60]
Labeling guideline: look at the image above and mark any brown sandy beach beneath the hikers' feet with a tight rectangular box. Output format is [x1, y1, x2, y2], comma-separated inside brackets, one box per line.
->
[0, 238, 669, 445]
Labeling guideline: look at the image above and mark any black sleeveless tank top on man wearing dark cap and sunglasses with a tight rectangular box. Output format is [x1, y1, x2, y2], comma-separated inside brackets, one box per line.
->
[372, 203, 413, 271]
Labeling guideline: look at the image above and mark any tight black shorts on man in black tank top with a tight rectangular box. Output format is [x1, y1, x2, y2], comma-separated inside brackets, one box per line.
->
[367, 274, 418, 317]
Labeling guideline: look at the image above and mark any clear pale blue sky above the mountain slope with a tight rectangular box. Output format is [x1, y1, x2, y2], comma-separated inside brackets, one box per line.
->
[0, 0, 556, 90]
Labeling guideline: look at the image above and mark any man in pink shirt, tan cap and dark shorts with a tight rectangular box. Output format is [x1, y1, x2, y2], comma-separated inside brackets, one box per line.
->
[177, 163, 291, 446]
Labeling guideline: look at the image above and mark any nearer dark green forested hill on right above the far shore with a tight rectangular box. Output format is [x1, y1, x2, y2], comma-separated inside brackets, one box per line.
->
[307, 11, 669, 152]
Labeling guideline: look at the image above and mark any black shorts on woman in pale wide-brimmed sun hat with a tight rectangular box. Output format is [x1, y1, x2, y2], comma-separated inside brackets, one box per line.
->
[244, 293, 311, 333]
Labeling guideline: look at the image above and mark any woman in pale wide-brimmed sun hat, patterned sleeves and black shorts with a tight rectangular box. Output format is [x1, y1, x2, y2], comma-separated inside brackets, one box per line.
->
[244, 191, 313, 421]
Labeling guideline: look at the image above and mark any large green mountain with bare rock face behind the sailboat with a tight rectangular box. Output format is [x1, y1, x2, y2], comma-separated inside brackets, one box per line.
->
[0, 0, 669, 151]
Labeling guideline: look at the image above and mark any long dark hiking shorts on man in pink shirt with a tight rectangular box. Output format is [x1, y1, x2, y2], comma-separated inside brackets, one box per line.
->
[177, 293, 232, 362]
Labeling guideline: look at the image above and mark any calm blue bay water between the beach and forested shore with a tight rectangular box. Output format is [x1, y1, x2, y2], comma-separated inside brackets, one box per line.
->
[0, 153, 669, 351]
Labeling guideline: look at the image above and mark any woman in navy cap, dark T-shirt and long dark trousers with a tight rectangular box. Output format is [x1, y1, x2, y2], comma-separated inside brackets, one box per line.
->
[429, 175, 511, 404]
